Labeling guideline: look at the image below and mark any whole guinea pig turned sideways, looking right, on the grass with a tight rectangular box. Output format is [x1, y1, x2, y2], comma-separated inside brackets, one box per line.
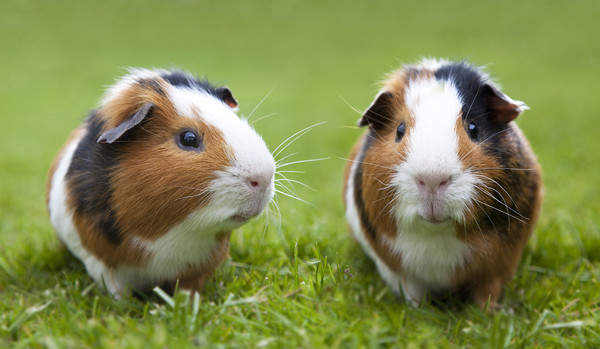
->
[46, 69, 275, 298]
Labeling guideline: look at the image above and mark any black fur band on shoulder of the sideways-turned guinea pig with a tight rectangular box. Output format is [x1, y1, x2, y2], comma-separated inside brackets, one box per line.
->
[66, 111, 123, 245]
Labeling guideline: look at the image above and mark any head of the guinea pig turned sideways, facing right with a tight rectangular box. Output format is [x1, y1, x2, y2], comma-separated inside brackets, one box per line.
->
[95, 69, 275, 236]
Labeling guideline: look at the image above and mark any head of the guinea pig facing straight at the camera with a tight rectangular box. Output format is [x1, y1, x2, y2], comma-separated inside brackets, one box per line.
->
[359, 60, 527, 229]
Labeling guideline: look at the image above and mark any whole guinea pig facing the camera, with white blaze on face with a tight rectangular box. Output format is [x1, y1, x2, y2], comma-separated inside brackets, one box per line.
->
[344, 59, 543, 310]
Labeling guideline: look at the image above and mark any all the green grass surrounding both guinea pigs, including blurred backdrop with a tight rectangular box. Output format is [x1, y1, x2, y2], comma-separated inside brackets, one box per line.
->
[0, 0, 600, 348]
